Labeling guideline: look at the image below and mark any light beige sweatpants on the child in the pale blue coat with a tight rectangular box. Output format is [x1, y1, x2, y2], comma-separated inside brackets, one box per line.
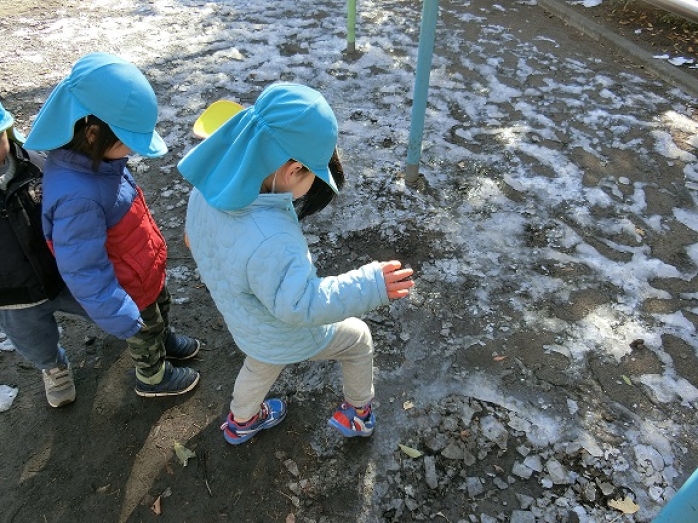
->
[230, 318, 373, 420]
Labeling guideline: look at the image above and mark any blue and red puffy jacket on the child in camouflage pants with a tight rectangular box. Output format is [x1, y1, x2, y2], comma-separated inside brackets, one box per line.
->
[42, 149, 167, 339]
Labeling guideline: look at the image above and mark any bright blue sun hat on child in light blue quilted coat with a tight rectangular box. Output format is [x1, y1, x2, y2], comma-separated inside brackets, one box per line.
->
[177, 83, 338, 211]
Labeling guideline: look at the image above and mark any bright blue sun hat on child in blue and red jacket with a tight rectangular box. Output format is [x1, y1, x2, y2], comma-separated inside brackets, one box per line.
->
[25, 53, 167, 157]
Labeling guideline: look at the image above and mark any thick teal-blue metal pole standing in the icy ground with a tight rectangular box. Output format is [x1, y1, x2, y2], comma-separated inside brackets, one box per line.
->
[405, 0, 439, 184]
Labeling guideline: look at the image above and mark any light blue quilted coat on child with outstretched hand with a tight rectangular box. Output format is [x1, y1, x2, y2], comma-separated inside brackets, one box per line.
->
[186, 189, 388, 364]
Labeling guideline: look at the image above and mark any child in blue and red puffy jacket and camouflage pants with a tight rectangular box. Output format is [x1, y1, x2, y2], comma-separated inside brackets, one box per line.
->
[26, 53, 200, 397]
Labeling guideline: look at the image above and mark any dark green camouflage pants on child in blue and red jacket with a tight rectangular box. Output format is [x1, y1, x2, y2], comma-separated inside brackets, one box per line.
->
[126, 285, 172, 383]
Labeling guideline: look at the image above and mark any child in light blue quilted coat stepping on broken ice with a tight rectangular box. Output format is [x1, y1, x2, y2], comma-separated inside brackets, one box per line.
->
[178, 83, 414, 445]
